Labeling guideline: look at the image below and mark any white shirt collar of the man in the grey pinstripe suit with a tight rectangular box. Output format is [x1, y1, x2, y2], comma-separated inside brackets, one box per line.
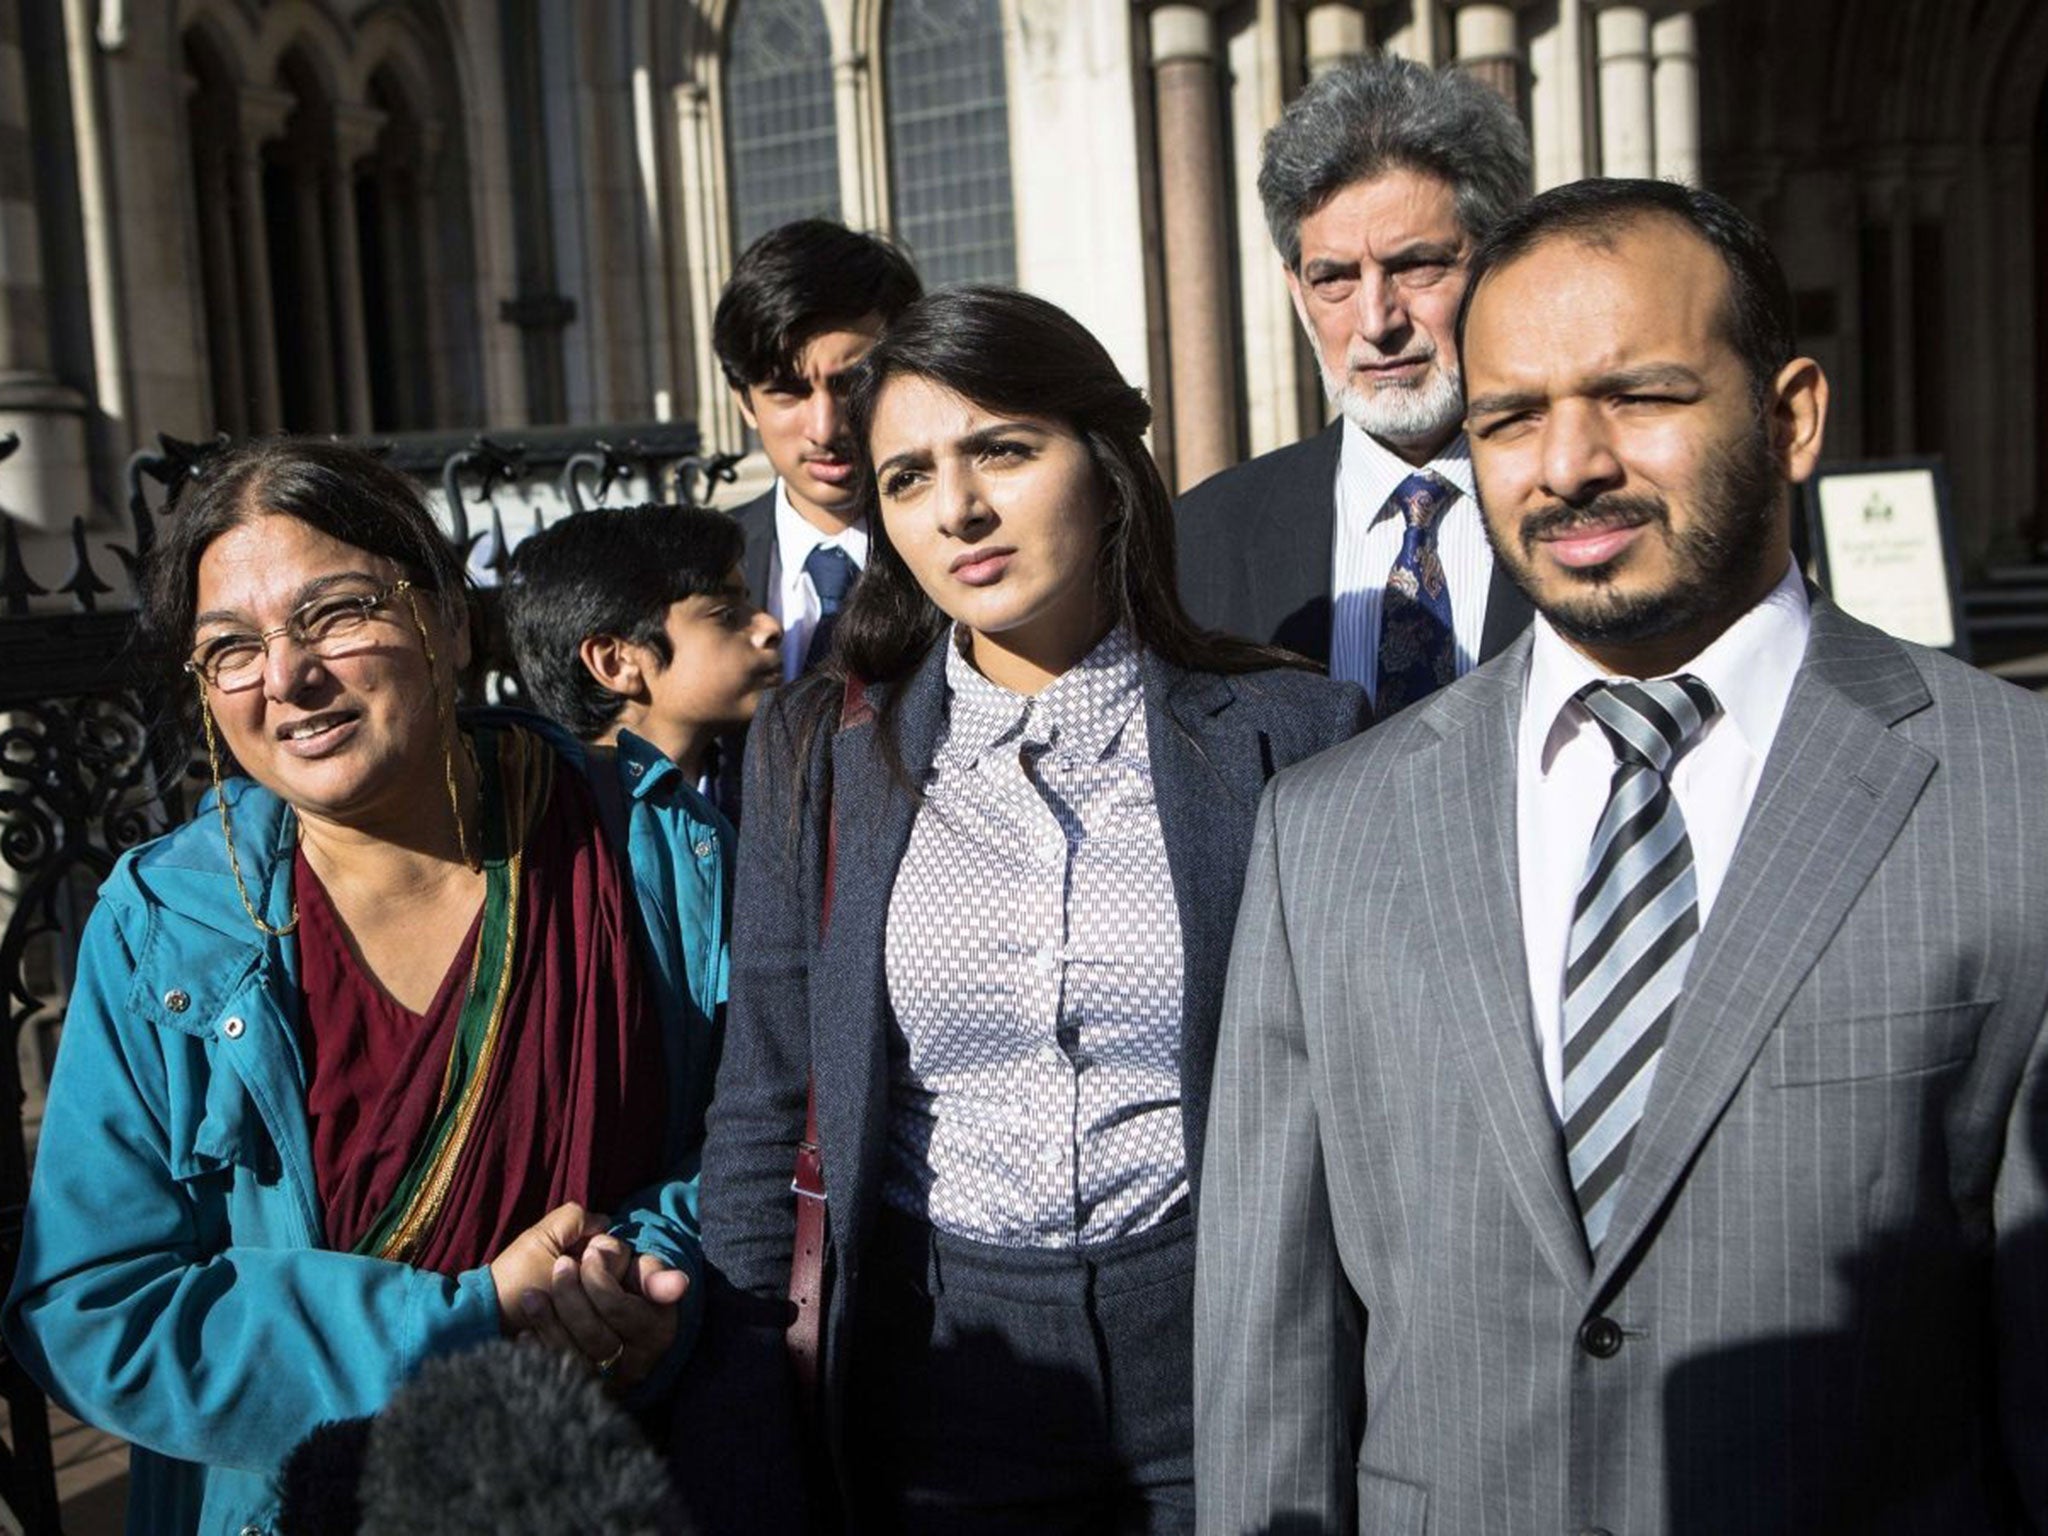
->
[1522, 563, 1812, 776]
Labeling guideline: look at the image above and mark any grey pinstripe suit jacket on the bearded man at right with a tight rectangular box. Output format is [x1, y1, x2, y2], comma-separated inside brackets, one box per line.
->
[1196, 600, 2048, 1536]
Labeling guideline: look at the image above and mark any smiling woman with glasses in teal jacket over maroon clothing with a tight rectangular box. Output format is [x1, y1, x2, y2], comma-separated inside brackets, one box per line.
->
[4, 442, 731, 1536]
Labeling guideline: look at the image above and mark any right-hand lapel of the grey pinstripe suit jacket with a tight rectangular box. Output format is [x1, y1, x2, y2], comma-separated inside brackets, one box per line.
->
[1595, 600, 1935, 1284]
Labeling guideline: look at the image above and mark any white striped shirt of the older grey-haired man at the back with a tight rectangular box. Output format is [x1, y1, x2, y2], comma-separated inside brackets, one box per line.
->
[1329, 422, 1493, 696]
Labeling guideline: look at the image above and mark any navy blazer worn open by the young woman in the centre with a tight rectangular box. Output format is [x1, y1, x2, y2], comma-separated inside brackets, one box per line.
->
[678, 643, 1370, 1532]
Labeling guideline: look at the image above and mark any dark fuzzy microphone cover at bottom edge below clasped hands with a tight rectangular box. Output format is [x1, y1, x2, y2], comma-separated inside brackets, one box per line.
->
[279, 1339, 688, 1536]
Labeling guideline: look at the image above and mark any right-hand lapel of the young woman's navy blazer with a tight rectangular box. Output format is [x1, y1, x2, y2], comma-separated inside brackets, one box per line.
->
[1141, 653, 1266, 1178]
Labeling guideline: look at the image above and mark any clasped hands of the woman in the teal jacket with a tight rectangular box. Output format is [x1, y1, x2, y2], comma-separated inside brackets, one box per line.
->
[492, 1204, 690, 1389]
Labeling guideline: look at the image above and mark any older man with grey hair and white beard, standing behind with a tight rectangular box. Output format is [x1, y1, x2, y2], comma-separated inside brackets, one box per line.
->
[1180, 59, 1530, 719]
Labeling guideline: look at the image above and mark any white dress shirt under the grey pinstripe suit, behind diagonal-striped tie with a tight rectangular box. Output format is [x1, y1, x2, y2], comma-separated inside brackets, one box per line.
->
[1516, 565, 1812, 1122]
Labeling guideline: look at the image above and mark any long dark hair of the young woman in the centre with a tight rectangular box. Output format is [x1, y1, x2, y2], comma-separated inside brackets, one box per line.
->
[799, 287, 1311, 766]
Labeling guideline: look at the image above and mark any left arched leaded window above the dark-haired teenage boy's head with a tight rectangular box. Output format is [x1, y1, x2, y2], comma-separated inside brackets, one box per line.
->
[725, 0, 840, 250]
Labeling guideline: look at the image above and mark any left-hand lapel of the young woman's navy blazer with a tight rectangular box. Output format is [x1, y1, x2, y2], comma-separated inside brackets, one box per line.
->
[811, 643, 946, 1243]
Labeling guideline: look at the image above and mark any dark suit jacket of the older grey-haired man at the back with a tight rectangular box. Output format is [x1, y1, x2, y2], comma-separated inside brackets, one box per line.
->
[1174, 422, 1530, 666]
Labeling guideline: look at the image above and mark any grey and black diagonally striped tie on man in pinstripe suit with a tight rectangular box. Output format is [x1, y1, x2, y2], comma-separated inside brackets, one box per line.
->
[1565, 676, 1720, 1253]
